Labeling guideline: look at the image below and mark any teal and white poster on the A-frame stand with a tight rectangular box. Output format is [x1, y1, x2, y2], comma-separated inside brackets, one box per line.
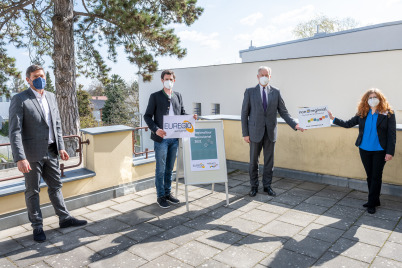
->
[190, 128, 220, 171]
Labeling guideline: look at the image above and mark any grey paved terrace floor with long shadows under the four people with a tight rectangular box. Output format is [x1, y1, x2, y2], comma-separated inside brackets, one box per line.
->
[0, 170, 402, 267]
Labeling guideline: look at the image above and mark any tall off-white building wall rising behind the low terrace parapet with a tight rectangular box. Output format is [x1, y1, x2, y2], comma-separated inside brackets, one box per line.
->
[139, 50, 402, 123]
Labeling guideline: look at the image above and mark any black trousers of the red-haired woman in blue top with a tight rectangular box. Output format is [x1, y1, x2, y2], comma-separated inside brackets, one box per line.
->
[359, 149, 386, 207]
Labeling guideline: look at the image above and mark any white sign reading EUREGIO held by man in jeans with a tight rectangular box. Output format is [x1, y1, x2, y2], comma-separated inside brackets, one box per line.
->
[163, 115, 195, 139]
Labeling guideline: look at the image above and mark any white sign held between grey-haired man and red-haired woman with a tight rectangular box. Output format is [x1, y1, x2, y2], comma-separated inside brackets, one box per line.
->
[298, 106, 331, 129]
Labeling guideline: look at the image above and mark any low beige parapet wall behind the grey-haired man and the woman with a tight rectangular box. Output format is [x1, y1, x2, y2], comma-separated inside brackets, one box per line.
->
[224, 120, 402, 185]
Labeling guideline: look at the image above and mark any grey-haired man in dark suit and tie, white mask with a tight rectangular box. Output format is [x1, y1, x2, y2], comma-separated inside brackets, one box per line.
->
[241, 66, 304, 197]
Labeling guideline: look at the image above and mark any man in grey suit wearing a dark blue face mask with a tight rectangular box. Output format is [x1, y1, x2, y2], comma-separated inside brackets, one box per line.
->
[9, 65, 87, 242]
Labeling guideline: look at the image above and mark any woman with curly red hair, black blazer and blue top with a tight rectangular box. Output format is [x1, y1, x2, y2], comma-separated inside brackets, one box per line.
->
[328, 88, 396, 214]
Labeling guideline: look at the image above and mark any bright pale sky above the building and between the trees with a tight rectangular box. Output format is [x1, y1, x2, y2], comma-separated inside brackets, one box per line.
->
[8, 0, 402, 86]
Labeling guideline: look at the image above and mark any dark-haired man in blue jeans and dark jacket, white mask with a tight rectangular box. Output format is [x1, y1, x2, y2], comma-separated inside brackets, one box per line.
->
[144, 70, 197, 208]
